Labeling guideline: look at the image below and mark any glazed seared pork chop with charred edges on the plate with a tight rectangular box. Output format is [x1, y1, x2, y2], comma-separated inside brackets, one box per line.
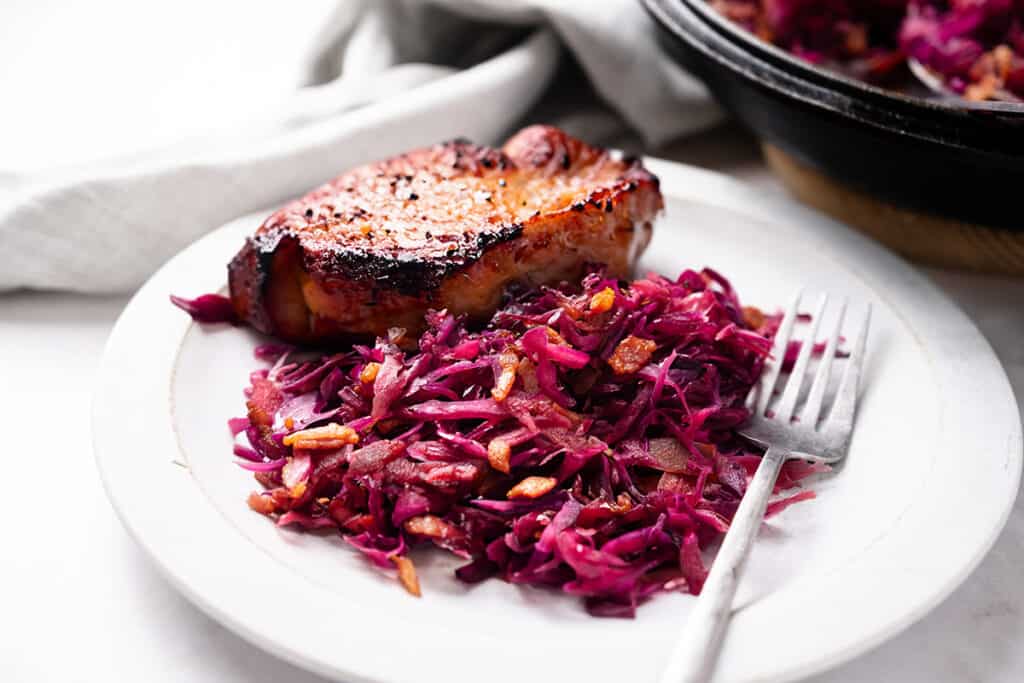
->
[228, 126, 663, 343]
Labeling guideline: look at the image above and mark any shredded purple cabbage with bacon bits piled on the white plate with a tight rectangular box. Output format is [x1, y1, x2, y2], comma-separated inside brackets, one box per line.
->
[218, 269, 821, 616]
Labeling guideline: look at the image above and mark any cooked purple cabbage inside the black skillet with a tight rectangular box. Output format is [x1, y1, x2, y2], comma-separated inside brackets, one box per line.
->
[709, 0, 1024, 100]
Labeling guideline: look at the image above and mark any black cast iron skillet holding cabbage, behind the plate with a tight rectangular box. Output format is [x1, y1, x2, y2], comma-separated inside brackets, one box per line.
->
[641, 0, 1024, 231]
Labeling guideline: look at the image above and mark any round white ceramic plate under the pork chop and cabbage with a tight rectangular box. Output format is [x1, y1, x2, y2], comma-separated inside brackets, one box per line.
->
[94, 160, 1021, 683]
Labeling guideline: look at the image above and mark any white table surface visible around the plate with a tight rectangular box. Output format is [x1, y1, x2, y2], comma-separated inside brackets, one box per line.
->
[8, 129, 1024, 683]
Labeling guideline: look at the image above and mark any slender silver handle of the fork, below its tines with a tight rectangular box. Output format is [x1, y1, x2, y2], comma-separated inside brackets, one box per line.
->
[659, 446, 791, 683]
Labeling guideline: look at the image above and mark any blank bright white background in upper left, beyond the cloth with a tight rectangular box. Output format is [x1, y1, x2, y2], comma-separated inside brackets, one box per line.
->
[0, 0, 335, 175]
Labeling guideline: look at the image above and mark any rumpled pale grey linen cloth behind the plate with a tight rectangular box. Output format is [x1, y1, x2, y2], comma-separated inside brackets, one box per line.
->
[0, 0, 718, 292]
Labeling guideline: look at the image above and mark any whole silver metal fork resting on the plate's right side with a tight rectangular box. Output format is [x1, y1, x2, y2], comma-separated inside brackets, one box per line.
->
[660, 294, 870, 683]
